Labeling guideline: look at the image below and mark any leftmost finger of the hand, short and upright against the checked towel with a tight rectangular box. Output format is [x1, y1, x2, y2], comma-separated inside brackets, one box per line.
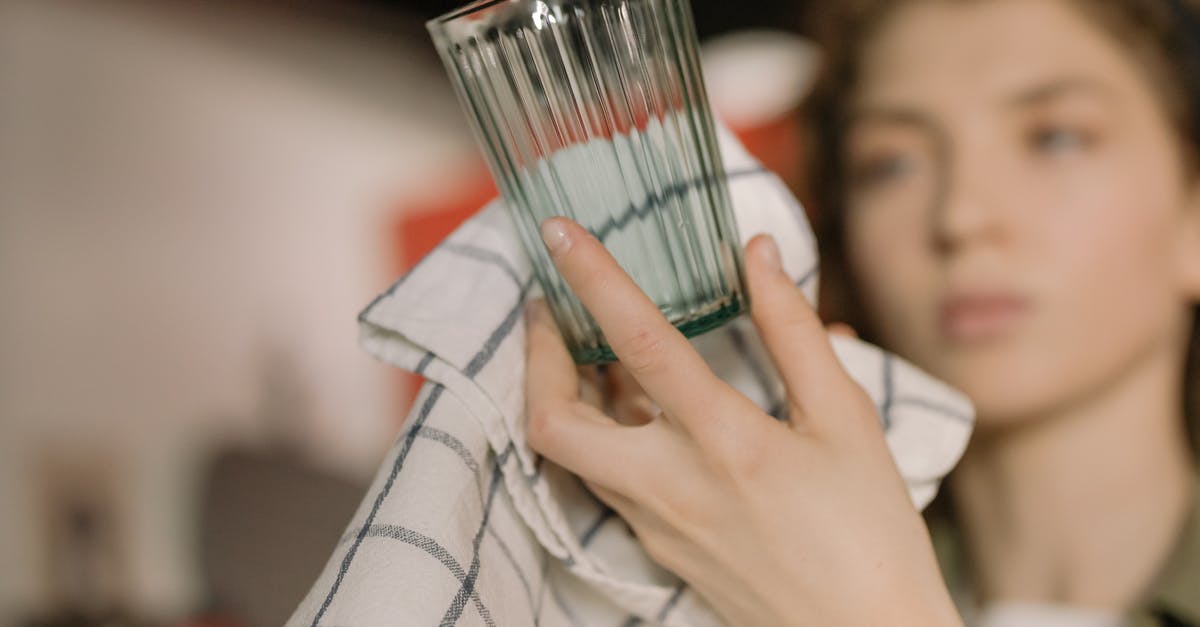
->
[526, 300, 580, 411]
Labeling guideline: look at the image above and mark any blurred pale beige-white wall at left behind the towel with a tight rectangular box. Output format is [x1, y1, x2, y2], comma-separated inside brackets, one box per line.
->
[0, 0, 474, 620]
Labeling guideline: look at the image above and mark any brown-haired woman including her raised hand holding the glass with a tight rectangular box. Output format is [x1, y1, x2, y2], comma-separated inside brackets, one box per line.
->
[527, 0, 1200, 626]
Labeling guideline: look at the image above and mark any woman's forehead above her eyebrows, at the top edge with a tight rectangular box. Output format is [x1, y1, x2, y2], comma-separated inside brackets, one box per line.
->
[856, 0, 1138, 111]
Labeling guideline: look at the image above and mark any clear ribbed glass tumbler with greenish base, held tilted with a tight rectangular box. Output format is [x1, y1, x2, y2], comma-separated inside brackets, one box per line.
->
[427, 0, 748, 364]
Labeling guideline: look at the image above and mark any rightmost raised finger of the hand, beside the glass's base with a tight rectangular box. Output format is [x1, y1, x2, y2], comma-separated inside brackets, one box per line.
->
[745, 235, 845, 414]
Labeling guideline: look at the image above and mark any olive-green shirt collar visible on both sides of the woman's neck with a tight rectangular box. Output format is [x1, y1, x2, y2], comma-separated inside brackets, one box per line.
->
[926, 480, 1200, 627]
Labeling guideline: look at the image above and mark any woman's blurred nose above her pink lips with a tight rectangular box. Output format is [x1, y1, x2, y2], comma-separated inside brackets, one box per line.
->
[930, 155, 1006, 255]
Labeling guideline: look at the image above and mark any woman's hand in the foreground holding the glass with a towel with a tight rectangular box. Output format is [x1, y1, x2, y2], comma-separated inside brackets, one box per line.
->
[526, 217, 961, 627]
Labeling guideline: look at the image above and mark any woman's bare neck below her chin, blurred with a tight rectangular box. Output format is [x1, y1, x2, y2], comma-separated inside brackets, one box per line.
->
[952, 341, 1194, 610]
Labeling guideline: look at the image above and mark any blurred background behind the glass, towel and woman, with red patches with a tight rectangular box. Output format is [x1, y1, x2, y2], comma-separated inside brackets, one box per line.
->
[0, 0, 818, 626]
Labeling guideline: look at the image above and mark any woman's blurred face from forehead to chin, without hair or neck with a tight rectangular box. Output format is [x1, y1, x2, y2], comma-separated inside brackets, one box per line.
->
[846, 0, 1200, 425]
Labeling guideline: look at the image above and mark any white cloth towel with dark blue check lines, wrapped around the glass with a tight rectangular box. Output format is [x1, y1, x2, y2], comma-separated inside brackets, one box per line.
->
[288, 131, 973, 627]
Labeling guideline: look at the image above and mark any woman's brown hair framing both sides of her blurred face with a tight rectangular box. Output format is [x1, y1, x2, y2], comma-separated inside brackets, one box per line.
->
[802, 0, 1200, 450]
